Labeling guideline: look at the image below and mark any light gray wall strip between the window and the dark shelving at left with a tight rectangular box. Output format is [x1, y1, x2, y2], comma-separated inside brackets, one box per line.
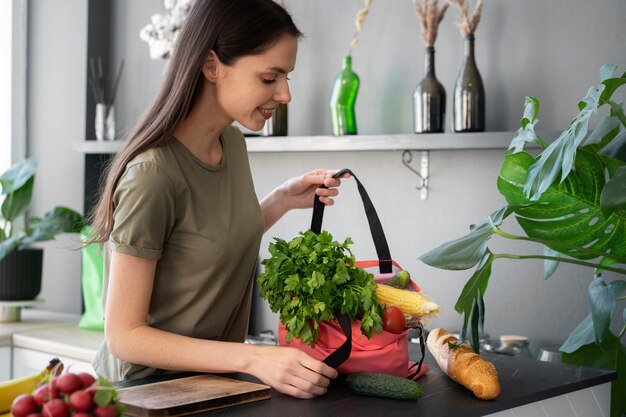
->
[27, 0, 87, 313]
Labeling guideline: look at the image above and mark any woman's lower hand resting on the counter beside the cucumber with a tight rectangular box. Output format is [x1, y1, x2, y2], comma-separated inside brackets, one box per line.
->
[248, 346, 337, 398]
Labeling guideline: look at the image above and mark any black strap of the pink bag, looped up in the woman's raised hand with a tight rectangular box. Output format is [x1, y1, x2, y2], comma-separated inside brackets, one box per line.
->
[311, 168, 393, 274]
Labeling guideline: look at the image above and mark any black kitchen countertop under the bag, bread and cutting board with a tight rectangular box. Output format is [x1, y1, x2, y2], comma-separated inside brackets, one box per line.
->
[116, 344, 617, 417]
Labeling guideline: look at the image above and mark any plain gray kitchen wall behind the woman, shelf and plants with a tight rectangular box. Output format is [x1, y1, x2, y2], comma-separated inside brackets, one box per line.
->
[29, 0, 626, 349]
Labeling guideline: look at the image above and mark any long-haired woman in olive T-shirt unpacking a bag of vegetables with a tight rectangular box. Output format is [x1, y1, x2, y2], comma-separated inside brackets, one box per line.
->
[92, 0, 339, 398]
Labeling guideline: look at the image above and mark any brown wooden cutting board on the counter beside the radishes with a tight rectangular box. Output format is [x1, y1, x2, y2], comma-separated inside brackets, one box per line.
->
[117, 375, 271, 417]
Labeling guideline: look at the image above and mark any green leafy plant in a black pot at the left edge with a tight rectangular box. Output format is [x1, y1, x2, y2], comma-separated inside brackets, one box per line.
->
[0, 159, 83, 301]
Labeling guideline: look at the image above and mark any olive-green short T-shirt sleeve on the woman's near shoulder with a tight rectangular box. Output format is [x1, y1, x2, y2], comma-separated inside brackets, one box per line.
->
[109, 161, 176, 259]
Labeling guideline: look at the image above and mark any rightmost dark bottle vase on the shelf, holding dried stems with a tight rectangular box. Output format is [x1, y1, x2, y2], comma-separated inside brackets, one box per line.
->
[453, 35, 485, 132]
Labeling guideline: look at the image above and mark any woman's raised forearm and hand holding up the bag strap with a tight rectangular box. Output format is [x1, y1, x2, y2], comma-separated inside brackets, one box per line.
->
[260, 169, 349, 231]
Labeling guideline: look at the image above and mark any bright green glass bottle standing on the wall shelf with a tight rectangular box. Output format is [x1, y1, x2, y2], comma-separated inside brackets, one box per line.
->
[330, 55, 359, 136]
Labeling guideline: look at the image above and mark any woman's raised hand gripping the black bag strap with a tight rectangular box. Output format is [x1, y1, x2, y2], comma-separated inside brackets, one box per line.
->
[281, 169, 350, 210]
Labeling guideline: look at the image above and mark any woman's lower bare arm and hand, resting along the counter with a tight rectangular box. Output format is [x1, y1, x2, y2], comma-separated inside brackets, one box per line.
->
[104, 253, 337, 398]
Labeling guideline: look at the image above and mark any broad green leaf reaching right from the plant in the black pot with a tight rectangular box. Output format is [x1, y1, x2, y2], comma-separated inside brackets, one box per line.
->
[20, 206, 84, 248]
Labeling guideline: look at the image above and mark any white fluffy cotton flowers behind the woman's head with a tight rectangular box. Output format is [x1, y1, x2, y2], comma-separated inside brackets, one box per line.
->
[139, 0, 195, 59]
